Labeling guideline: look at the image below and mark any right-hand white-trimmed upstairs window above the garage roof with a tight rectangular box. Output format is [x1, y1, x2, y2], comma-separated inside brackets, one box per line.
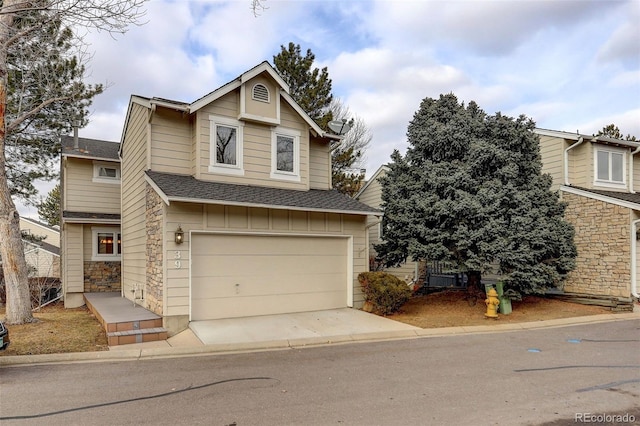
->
[271, 127, 300, 182]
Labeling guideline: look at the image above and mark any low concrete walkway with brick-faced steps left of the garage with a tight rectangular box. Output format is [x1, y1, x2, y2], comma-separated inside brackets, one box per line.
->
[84, 293, 168, 346]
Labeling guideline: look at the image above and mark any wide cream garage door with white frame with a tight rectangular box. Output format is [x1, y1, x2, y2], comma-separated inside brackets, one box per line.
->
[191, 234, 349, 321]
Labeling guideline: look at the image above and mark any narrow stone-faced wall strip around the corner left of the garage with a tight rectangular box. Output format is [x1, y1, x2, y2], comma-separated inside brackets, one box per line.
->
[144, 185, 164, 315]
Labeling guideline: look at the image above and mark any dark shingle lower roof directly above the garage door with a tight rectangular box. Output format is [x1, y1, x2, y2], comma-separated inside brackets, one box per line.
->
[147, 170, 381, 214]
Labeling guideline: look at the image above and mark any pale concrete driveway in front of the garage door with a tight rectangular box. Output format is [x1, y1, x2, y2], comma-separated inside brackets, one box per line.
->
[189, 308, 419, 345]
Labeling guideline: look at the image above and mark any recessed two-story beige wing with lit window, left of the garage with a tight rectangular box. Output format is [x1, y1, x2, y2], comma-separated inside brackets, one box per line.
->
[60, 135, 121, 308]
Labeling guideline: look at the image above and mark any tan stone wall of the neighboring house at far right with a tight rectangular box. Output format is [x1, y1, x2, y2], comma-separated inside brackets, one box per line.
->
[562, 192, 631, 297]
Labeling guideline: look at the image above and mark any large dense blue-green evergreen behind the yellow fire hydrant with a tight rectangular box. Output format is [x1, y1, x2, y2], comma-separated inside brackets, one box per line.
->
[376, 94, 576, 294]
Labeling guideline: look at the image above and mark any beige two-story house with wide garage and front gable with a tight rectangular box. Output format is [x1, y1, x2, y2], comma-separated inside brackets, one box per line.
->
[63, 62, 379, 334]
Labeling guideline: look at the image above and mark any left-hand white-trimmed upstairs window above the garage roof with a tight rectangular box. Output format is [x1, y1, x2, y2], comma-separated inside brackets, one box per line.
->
[209, 116, 244, 175]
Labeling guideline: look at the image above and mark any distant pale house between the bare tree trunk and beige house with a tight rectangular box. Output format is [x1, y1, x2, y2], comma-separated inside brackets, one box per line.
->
[20, 217, 60, 278]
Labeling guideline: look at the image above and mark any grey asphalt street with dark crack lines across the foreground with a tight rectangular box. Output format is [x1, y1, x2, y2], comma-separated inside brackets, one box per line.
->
[0, 320, 640, 426]
